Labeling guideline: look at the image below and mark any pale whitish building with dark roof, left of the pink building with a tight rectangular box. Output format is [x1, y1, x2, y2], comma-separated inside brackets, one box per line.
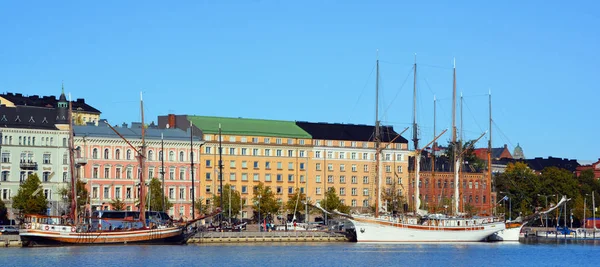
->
[0, 91, 75, 219]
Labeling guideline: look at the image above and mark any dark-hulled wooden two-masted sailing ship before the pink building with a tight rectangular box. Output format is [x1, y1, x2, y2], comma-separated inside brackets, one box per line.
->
[20, 94, 220, 246]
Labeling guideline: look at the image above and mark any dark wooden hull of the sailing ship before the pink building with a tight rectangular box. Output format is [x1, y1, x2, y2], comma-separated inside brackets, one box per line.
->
[20, 227, 186, 249]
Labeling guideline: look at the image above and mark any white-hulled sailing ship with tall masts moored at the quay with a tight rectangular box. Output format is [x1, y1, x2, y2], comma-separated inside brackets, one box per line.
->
[334, 55, 506, 242]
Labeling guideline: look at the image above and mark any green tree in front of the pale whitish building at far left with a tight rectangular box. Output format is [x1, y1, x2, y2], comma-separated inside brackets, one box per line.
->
[13, 174, 48, 217]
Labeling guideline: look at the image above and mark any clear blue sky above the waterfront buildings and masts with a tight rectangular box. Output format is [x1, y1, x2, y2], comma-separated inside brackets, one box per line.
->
[0, 1, 600, 160]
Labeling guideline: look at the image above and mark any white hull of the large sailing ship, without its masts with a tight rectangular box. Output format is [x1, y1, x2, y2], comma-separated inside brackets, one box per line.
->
[351, 220, 505, 243]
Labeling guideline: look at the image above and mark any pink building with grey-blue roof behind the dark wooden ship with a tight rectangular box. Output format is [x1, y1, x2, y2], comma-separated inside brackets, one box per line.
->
[73, 123, 202, 220]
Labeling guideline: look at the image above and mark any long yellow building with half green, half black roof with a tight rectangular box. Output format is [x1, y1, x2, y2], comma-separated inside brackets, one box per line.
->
[159, 115, 409, 218]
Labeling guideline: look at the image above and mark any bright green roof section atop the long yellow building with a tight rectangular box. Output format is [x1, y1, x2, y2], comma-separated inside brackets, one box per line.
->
[187, 116, 312, 138]
